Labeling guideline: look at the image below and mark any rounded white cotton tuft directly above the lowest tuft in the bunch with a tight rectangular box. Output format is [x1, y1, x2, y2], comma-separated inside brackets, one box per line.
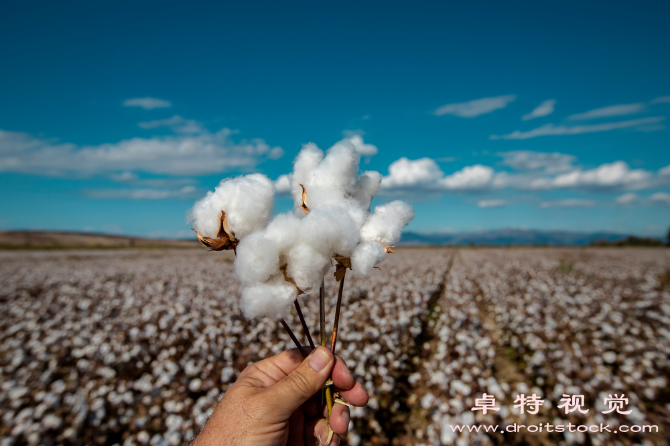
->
[235, 232, 279, 284]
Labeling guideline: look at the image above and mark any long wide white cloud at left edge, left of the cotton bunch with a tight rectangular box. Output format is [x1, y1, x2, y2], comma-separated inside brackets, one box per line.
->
[0, 129, 284, 175]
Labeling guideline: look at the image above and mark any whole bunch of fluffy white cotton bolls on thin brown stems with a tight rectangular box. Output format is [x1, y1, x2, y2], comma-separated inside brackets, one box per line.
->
[190, 140, 414, 444]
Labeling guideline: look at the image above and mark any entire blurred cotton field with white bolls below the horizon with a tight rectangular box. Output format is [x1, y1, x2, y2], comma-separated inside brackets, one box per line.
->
[0, 248, 670, 446]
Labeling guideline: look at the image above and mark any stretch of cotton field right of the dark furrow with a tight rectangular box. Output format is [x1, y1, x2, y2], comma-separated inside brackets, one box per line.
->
[409, 249, 670, 445]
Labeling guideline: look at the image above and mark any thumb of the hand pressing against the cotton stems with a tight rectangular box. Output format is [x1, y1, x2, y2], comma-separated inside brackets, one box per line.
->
[263, 346, 335, 420]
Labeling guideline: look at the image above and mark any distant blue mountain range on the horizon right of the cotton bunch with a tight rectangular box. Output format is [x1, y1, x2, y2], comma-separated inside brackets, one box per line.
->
[400, 228, 628, 246]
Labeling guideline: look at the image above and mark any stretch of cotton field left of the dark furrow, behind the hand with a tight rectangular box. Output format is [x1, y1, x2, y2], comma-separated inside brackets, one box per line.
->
[0, 250, 444, 446]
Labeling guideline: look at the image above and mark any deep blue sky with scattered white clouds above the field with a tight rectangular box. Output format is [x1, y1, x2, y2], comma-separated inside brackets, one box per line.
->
[0, 1, 670, 237]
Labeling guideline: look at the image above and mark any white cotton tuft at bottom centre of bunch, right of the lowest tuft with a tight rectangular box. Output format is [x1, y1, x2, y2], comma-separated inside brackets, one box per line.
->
[286, 243, 330, 292]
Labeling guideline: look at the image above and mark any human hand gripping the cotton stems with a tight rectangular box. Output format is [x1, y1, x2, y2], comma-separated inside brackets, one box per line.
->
[192, 347, 368, 446]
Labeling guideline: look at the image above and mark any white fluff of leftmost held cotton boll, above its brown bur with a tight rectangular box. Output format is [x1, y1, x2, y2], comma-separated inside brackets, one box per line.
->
[188, 173, 274, 239]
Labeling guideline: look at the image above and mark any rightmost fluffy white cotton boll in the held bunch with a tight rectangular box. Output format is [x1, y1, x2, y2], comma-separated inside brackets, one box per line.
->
[361, 201, 414, 246]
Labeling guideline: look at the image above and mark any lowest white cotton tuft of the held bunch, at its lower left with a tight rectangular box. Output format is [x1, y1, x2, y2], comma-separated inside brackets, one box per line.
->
[242, 275, 298, 320]
